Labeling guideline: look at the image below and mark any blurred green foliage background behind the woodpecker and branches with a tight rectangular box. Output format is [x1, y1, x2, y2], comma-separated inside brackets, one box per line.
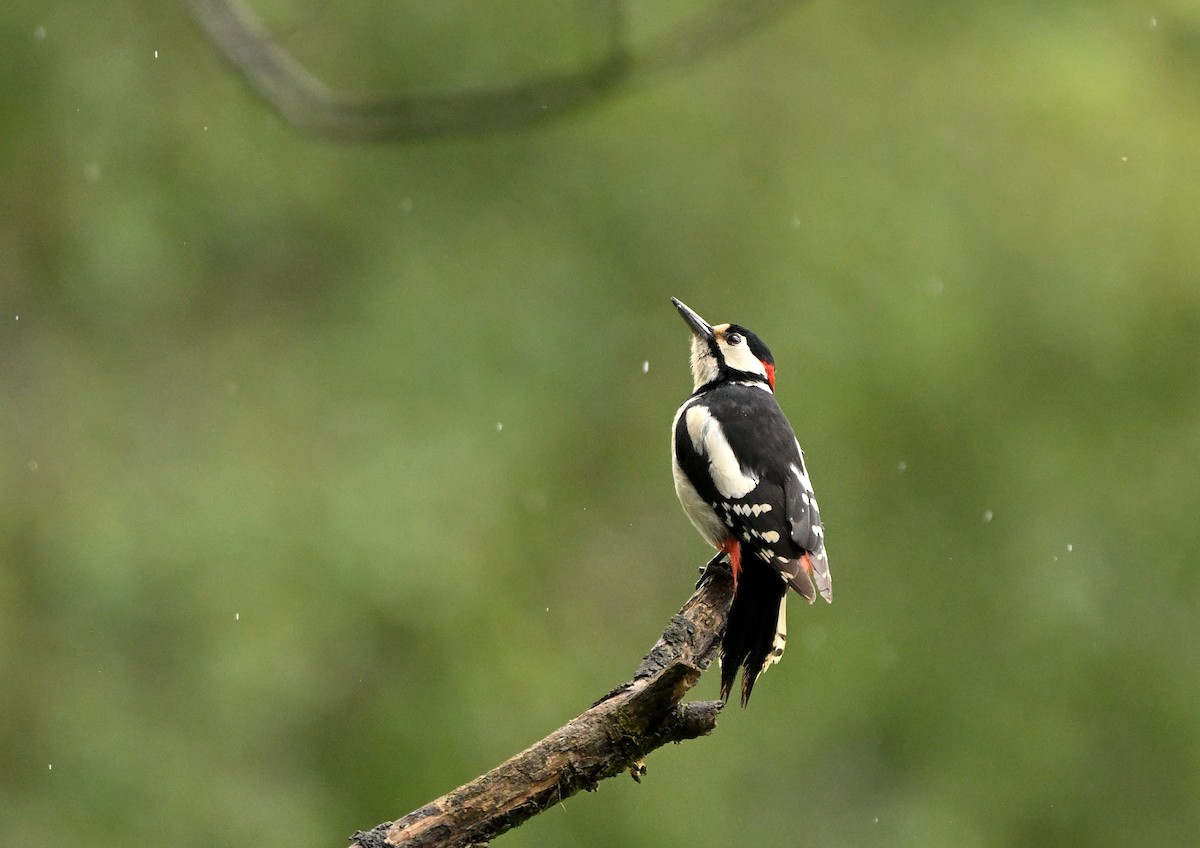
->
[0, 0, 1200, 848]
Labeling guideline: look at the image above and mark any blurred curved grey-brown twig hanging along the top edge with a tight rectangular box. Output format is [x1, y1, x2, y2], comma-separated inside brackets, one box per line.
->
[186, 0, 798, 142]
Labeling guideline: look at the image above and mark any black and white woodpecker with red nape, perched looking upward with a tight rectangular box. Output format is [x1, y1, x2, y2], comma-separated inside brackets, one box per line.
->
[671, 297, 833, 705]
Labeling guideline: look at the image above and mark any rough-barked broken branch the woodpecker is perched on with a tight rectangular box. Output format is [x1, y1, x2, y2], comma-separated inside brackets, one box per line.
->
[352, 570, 733, 848]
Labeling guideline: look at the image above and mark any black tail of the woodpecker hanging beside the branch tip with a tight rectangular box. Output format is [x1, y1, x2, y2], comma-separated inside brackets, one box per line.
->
[721, 558, 787, 706]
